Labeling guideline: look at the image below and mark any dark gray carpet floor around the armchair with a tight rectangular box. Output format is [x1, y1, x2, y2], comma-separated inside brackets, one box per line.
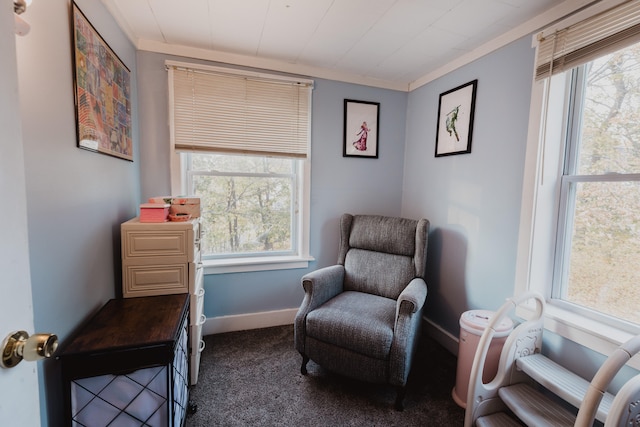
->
[186, 325, 464, 427]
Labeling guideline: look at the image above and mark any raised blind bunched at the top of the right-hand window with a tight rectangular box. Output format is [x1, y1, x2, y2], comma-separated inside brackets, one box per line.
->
[536, 0, 640, 80]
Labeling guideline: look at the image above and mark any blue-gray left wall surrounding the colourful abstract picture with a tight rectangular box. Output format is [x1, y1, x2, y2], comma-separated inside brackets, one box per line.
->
[15, 0, 140, 426]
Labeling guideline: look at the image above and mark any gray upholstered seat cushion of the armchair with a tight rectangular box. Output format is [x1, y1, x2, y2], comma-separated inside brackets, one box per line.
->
[306, 291, 396, 360]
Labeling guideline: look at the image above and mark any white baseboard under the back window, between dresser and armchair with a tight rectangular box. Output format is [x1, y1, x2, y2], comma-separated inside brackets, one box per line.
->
[202, 308, 298, 335]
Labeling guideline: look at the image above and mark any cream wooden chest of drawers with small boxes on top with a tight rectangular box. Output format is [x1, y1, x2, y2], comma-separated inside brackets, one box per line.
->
[120, 217, 206, 385]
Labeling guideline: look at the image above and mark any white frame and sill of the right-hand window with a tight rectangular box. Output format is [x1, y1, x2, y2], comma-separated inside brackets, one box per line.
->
[514, 51, 640, 369]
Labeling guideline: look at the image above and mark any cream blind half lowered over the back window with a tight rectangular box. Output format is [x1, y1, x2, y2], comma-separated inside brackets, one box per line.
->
[167, 62, 313, 158]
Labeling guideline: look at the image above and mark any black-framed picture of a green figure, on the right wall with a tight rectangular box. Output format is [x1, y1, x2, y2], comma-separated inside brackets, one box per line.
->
[436, 79, 478, 157]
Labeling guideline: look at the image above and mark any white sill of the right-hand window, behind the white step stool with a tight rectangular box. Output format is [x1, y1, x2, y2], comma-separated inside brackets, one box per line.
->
[516, 303, 640, 370]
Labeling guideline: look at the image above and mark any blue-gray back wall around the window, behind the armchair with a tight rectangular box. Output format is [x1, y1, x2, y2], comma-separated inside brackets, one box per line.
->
[138, 51, 408, 318]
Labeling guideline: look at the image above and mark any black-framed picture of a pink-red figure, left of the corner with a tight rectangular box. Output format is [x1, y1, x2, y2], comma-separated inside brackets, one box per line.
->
[342, 99, 380, 159]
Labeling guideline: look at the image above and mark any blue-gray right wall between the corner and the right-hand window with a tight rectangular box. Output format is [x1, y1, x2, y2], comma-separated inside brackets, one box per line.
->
[402, 37, 534, 336]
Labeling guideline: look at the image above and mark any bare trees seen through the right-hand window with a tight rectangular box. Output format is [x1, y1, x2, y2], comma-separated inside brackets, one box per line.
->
[561, 44, 640, 323]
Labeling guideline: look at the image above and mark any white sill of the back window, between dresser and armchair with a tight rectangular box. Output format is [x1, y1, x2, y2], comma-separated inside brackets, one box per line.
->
[202, 256, 314, 274]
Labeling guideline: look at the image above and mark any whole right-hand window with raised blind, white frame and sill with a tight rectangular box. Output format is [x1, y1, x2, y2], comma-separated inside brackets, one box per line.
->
[514, 0, 640, 369]
